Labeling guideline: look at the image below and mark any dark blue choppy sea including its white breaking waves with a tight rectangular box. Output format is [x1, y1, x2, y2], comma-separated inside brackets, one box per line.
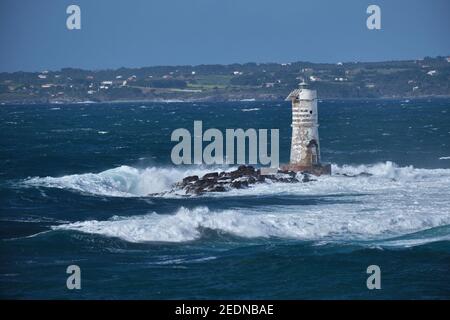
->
[0, 99, 450, 299]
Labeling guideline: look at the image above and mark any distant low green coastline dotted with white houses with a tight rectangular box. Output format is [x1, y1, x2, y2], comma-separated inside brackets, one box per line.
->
[0, 57, 450, 104]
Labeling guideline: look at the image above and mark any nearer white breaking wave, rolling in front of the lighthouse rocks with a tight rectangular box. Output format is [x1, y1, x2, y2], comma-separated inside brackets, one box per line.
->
[53, 207, 450, 246]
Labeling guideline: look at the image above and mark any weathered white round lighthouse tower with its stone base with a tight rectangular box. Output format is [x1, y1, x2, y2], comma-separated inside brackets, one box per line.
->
[283, 82, 331, 175]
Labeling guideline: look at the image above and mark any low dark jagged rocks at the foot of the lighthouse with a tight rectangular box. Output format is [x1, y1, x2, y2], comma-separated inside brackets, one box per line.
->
[175, 165, 312, 195]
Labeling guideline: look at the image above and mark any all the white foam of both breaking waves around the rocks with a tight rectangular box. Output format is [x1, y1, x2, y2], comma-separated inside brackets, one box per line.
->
[25, 162, 450, 246]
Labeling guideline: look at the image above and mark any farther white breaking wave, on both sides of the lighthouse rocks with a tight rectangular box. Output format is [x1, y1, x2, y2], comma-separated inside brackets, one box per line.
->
[23, 161, 450, 197]
